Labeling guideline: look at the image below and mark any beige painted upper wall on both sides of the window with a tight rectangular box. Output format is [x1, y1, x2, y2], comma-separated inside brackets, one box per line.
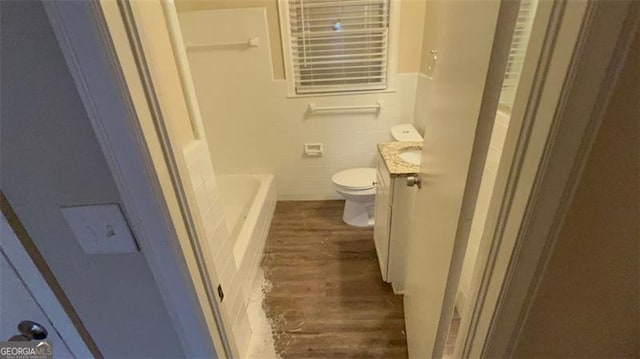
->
[175, 0, 426, 79]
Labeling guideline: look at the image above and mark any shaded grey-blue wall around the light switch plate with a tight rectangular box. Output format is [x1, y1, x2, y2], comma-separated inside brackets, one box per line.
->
[0, 1, 184, 358]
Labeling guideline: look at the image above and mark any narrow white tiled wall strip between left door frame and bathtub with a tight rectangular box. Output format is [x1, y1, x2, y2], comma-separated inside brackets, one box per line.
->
[183, 141, 251, 356]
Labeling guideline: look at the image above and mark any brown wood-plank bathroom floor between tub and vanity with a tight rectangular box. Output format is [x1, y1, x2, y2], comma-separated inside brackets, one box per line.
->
[262, 201, 407, 358]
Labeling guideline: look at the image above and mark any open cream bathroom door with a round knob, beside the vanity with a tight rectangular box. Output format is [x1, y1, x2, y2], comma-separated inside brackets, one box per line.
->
[404, 0, 508, 358]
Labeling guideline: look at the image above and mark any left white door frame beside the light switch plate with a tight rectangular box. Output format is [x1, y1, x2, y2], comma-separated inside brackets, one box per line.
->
[43, 1, 232, 358]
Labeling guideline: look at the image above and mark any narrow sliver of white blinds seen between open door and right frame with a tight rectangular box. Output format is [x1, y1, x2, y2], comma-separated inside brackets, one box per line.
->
[500, 0, 537, 108]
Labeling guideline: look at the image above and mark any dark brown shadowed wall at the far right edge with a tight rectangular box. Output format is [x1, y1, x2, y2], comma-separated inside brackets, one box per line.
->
[515, 29, 640, 358]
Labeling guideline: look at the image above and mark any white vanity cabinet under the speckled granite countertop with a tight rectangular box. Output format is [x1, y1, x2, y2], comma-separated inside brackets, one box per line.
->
[373, 150, 416, 294]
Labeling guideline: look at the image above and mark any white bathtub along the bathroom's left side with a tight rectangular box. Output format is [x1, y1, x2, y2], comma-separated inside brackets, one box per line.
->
[216, 174, 277, 298]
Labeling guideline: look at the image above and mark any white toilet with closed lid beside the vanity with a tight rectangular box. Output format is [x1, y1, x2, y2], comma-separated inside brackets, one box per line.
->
[331, 124, 422, 227]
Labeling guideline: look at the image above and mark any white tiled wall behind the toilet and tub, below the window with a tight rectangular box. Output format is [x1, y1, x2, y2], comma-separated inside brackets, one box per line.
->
[180, 9, 416, 199]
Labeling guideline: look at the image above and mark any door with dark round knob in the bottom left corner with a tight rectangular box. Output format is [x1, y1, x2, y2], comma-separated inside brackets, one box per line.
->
[0, 215, 93, 358]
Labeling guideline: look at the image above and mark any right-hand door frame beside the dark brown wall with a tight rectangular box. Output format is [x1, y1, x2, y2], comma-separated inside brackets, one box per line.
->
[454, 0, 640, 358]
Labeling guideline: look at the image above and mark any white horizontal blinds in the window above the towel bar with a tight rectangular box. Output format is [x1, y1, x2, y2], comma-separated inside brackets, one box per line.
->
[288, 0, 389, 94]
